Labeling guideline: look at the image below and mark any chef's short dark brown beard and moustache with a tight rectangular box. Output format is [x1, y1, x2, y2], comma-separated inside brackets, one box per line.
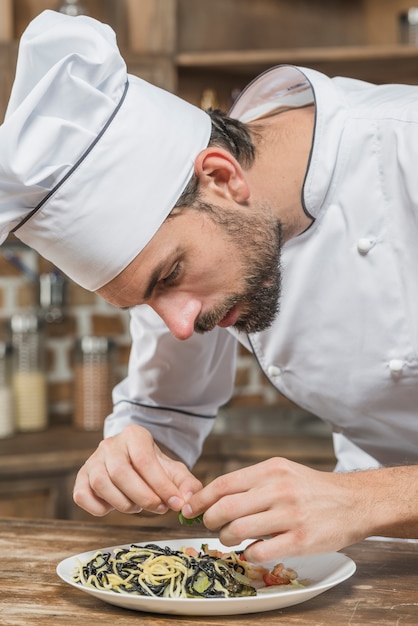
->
[191, 204, 282, 333]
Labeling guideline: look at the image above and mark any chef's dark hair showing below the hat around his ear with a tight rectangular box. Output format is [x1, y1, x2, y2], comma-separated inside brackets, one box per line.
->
[174, 109, 255, 208]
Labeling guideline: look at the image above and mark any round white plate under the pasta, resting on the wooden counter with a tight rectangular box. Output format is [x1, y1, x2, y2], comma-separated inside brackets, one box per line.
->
[57, 537, 356, 616]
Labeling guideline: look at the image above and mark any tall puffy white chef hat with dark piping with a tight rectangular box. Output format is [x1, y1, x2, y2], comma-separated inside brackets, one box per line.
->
[0, 11, 211, 291]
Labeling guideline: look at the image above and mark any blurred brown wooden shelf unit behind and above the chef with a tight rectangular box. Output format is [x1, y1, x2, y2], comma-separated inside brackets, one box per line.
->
[123, 0, 418, 110]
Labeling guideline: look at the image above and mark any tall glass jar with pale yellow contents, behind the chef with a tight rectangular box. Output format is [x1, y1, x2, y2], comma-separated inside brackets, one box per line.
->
[11, 313, 48, 432]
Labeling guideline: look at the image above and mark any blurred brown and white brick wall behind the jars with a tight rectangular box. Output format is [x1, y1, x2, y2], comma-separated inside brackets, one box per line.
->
[0, 239, 290, 423]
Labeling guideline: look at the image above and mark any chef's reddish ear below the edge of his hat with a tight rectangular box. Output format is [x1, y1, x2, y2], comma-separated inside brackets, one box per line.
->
[194, 146, 250, 203]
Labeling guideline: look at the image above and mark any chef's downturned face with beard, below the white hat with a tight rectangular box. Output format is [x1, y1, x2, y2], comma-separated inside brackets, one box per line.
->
[98, 205, 281, 339]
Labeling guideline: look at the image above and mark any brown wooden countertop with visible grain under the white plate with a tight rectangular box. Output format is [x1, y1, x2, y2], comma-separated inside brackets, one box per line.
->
[0, 519, 418, 626]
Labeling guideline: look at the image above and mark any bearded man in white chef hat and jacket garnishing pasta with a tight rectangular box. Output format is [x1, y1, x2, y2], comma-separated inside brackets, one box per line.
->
[0, 11, 418, 561]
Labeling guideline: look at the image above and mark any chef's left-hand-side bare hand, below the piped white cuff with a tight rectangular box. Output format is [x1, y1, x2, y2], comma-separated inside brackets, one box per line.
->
[73, 424, 202, 516]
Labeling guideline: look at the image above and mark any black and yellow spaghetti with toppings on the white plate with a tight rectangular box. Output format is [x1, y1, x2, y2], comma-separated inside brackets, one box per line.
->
[72, 544, 301, 598]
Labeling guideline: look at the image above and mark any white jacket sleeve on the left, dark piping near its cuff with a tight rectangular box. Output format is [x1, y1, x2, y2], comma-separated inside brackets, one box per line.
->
[104, 305, 237, 467]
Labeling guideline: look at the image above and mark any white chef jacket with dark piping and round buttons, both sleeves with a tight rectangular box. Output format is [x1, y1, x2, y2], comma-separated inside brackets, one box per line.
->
[105, 66, 418, 470]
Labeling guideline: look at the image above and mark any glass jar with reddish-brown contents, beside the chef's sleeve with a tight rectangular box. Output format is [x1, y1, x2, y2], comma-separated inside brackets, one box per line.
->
[74, 336, 115, 430]
